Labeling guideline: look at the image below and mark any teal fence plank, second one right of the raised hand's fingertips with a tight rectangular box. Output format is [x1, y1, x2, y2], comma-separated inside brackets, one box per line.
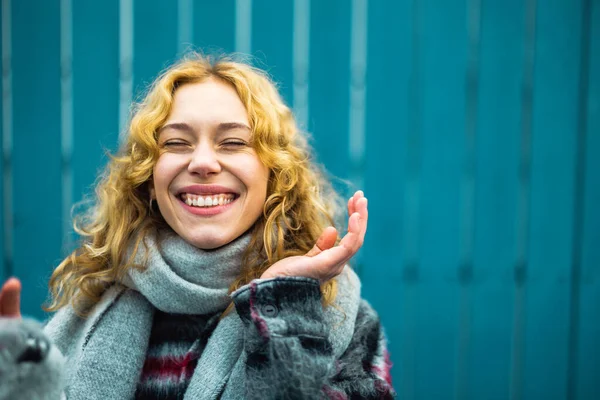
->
[416, 0, 468, 398]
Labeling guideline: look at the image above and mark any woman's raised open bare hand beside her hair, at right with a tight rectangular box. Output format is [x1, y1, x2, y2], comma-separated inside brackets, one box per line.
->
[261, 190, 369, 283]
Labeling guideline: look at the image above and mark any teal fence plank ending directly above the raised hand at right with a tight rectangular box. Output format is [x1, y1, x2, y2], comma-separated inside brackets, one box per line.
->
[308, 0, 351, 188]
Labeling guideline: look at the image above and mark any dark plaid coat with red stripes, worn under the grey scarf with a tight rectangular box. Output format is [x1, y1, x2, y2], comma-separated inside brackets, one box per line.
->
[135, 280, 395, 400]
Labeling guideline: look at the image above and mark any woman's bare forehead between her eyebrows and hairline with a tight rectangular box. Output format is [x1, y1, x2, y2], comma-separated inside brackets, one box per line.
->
[167, 78, 248, 123]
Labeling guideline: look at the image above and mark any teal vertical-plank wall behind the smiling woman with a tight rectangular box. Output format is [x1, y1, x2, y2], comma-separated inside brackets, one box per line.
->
[0, 0, 600, 399]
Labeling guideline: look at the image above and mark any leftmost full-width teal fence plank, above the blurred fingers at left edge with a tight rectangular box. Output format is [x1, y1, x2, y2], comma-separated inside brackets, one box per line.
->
[12, 0, 63, 317]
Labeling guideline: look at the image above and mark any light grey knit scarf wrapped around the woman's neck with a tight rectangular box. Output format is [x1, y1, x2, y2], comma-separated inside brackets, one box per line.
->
[45, 230, 360, 400]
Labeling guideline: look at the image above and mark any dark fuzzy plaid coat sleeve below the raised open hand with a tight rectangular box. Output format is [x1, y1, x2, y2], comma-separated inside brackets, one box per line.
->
[233, 277, 395, 400]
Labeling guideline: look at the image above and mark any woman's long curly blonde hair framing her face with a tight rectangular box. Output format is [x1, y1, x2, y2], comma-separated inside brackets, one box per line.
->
[45, 53, 343, 314]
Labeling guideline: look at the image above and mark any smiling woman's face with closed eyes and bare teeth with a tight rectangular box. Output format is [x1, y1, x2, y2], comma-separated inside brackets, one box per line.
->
[151, 78, 269, 249]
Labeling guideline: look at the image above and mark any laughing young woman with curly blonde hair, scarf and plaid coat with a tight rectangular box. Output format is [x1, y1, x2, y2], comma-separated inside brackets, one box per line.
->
[0, 55, 394, 400]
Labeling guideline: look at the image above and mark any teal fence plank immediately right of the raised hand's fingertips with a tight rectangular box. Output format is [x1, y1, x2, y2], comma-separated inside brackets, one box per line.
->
[361, 0, 420, 392]
